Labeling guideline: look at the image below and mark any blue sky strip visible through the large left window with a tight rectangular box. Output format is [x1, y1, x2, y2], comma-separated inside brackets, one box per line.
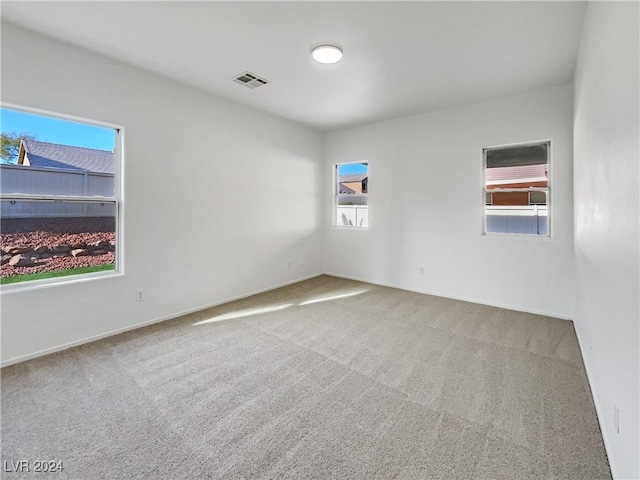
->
[0, 108, 115, 151]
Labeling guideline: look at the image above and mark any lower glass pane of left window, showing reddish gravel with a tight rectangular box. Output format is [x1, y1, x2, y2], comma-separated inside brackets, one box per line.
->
[0, 200, 116, 284]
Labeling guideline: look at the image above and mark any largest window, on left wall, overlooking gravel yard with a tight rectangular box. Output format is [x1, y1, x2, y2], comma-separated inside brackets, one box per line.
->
[0, 107, 121, 285]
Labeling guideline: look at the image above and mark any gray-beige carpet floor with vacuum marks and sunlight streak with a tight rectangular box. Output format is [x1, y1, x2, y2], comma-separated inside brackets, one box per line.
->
[2, 276, 611, 480]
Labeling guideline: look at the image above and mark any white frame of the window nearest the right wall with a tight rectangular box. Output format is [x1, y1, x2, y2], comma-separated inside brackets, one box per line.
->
[482, 139, 553, 239]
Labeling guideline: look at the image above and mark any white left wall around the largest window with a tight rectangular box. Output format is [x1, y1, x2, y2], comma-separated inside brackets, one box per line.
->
[2, 24, 322, 364]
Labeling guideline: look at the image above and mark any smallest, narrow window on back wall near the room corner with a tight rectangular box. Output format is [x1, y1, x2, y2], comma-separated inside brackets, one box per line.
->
[334, 162, 369, 228]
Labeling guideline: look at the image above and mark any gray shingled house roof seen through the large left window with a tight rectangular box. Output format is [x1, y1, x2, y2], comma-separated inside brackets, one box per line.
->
[19, 140, 116, 174]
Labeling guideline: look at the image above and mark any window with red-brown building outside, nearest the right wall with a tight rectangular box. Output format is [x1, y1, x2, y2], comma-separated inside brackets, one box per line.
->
[484, 142, 551, 236]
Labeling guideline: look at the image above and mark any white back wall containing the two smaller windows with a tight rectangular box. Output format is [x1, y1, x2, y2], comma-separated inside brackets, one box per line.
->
[324, 85, 574, 318]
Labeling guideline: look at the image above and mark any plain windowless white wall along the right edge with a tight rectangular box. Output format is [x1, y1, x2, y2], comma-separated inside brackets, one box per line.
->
[574, 2, 640, 479]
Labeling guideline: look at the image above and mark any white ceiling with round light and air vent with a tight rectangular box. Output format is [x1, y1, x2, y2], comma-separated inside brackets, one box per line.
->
[1, 1, 586, 131]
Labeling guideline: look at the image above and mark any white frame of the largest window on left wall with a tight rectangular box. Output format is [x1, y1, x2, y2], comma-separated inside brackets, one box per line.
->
[0, 102, 124, 293]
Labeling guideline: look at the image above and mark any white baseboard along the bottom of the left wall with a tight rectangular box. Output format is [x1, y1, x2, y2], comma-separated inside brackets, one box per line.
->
[0, 273, 323, 368]
